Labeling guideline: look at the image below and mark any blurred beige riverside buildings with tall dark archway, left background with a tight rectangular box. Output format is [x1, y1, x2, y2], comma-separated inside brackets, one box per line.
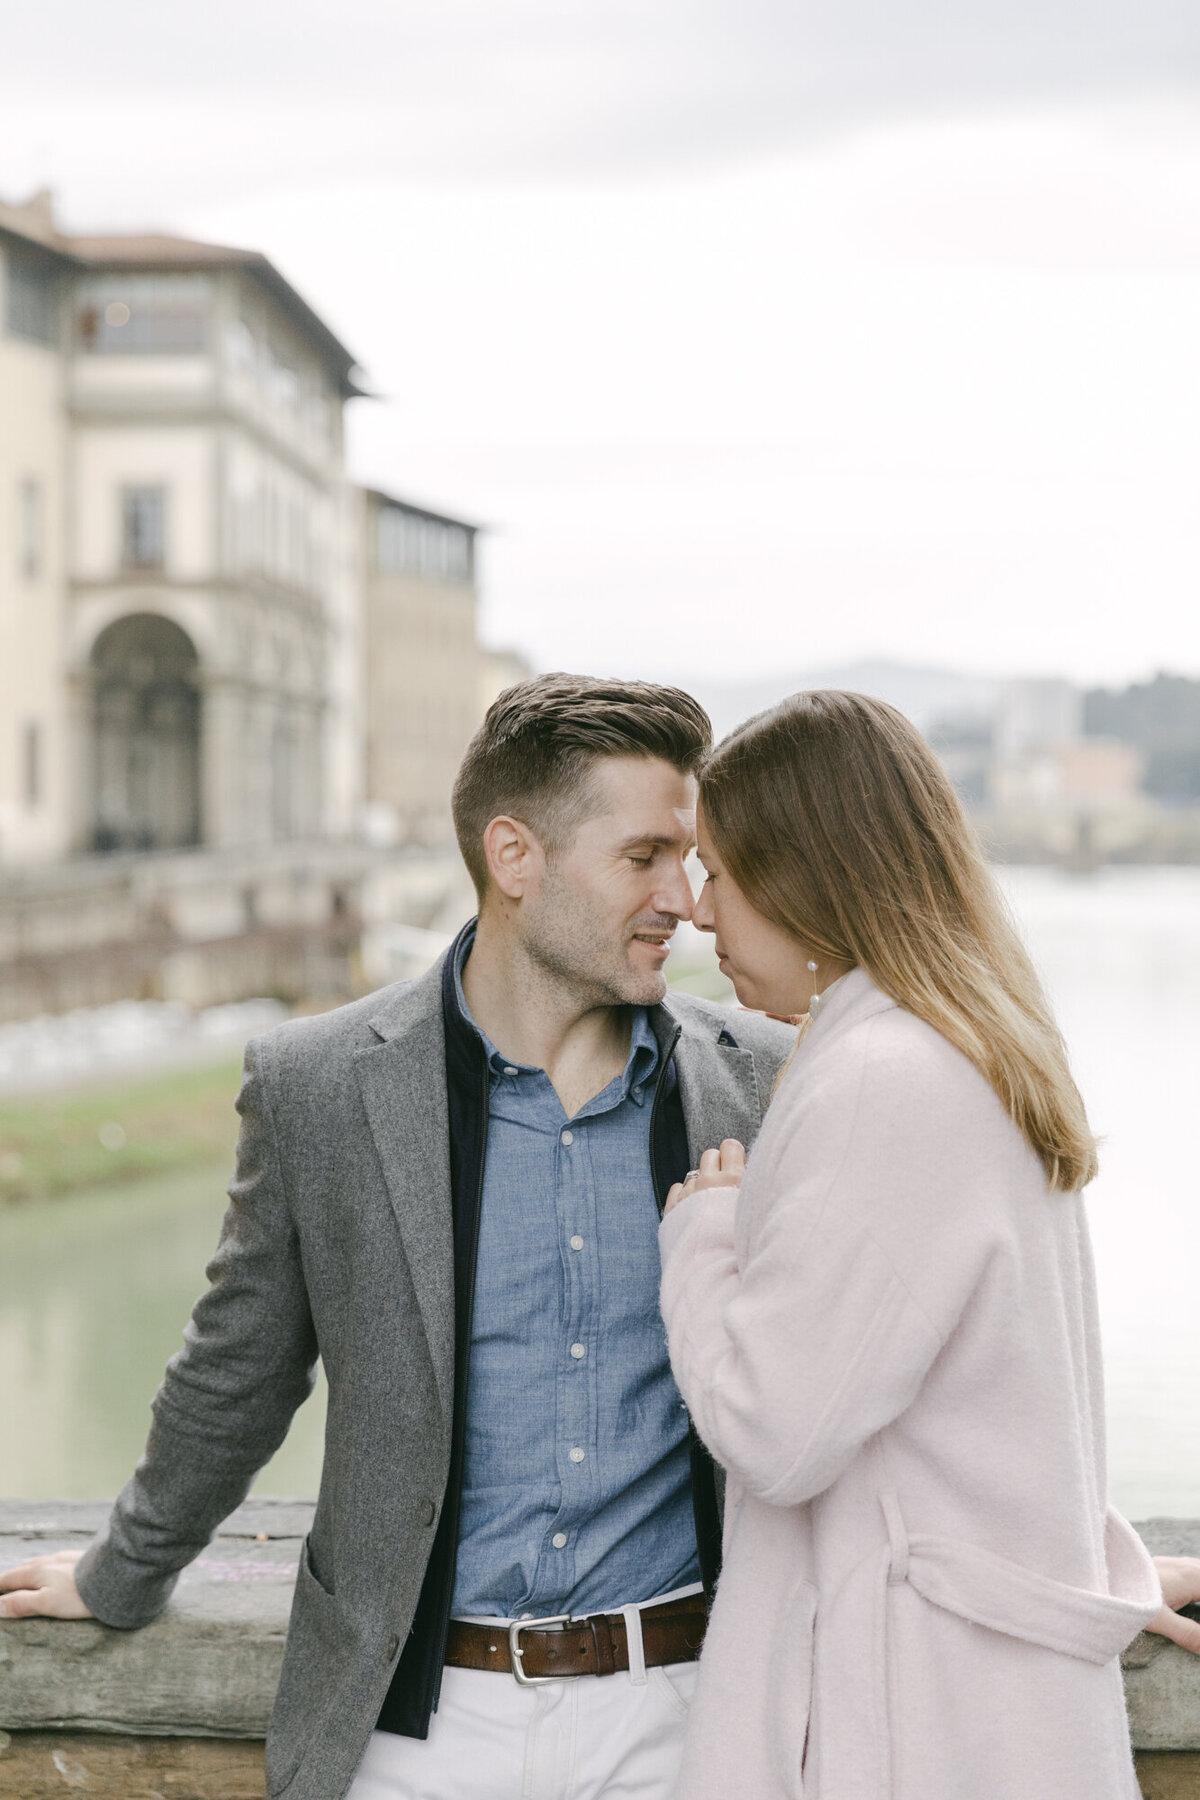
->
[0, 196, 518, 864]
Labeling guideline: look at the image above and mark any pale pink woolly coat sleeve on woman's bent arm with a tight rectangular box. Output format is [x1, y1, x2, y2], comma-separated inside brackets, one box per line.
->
[660, 1029, 982, 1505]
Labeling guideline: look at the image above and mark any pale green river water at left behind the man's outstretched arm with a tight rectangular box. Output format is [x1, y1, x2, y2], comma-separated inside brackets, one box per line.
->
[0, 1165, 324, 1499]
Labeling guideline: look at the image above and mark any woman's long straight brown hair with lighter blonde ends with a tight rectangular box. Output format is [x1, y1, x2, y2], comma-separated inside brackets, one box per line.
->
[700, 689, 1096, 1190]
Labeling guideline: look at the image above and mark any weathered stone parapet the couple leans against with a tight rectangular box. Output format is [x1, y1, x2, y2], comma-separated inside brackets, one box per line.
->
[0, 1499, 1200, 1800]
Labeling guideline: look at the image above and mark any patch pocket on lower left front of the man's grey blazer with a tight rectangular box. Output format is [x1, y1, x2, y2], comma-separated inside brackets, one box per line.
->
[266, 1537, 356, 1795]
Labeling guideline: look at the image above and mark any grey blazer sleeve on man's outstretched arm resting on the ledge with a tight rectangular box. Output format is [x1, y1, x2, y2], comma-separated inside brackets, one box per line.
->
[76, 1039, 317, 1627]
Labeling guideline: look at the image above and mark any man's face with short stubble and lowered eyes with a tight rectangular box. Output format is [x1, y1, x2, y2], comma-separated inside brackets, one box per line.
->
[518, 756, 696, 1006]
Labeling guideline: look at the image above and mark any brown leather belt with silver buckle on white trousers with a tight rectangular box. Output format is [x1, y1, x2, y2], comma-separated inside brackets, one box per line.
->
[446, 1593, 709, 1687]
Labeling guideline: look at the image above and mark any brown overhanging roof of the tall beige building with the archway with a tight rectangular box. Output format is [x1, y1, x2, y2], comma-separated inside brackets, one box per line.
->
[0, 191, 365, 398]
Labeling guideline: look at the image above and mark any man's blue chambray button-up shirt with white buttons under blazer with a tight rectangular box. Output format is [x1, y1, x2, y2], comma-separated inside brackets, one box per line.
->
[453, 941, 700, 1618]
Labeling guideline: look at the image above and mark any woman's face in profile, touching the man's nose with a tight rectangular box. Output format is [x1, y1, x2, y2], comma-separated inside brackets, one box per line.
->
[693, 808, 827, 1019]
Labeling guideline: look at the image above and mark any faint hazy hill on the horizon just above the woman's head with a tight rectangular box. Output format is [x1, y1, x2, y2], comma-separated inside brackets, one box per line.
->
[684, 661, 1006, 738]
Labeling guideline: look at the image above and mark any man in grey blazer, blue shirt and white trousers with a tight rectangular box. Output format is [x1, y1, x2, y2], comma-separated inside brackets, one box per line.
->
[4, 675, 793, 1800]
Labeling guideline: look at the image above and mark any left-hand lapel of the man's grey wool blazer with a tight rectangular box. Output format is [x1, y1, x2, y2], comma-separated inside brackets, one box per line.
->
[358, 963, 453, 1417]
